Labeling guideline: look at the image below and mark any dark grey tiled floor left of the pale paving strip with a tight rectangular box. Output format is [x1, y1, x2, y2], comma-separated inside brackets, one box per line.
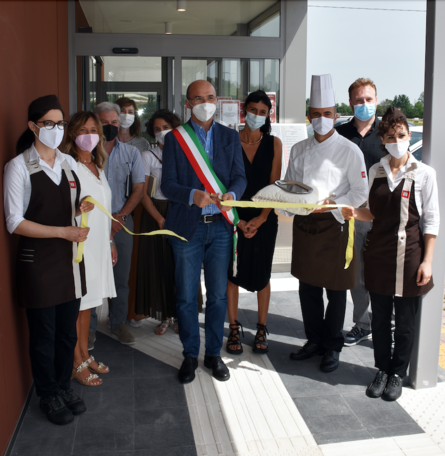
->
[11, 333, 197, 456]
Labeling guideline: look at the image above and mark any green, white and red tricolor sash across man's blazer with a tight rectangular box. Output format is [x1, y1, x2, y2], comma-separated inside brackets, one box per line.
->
[173, 123, 239, 276]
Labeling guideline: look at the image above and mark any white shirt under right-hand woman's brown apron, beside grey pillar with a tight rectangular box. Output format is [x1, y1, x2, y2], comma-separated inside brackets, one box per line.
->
[369, 153, 440, 236]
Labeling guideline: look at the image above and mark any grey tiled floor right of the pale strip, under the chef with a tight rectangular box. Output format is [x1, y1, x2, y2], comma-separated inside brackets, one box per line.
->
[222, 291, 423, 445]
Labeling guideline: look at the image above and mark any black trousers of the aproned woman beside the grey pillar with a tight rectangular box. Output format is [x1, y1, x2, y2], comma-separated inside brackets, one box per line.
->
[370, 293, 421, 378]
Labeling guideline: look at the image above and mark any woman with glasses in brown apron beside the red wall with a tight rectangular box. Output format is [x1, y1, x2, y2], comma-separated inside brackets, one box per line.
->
[3, 95, 94, 424]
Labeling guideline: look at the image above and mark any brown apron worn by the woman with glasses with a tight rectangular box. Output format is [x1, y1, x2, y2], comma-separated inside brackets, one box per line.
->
[17, 150, 86, 309]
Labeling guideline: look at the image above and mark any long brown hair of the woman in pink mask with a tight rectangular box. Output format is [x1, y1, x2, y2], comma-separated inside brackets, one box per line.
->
[65, 111, 107, 169]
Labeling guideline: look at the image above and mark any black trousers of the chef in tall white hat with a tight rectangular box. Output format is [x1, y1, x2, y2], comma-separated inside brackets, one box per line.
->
[299, 280, 346, 352]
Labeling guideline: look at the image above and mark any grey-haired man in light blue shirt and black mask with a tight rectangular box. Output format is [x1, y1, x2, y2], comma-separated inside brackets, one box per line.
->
[87, 102, 145, 345]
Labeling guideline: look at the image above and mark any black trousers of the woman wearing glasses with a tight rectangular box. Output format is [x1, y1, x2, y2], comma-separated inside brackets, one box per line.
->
[26, 299, 80, 398]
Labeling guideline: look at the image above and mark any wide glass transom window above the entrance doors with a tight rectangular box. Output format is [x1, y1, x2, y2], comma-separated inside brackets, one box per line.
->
[76, 0, 280, 37]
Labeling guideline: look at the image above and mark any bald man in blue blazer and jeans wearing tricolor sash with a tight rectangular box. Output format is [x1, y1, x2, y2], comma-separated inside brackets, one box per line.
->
[161, 80, 247, 383]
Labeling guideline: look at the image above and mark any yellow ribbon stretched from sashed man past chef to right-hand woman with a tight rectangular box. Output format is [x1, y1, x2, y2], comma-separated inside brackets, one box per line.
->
[220, 200, 355, 269]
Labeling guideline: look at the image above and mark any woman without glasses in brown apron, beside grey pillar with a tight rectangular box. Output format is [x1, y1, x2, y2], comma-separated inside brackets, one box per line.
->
[343, 108, 439, 401]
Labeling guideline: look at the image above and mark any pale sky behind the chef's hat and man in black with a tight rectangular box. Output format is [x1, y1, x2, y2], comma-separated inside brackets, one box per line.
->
[306, 0, 426, 104]
